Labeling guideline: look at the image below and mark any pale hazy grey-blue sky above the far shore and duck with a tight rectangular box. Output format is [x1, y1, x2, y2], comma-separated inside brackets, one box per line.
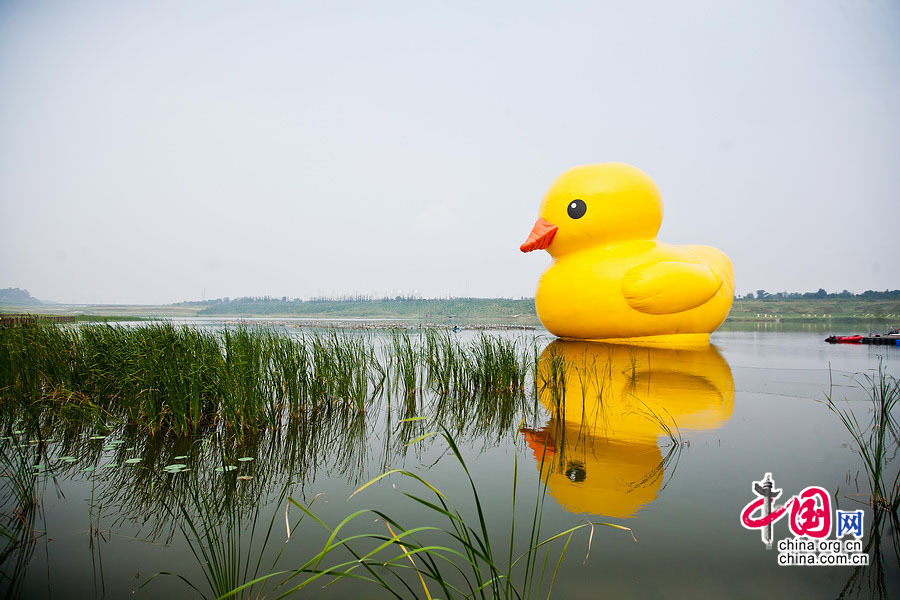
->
[0, 0, 900, 304]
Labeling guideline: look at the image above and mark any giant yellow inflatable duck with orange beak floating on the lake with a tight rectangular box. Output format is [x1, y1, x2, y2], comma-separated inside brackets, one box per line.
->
[520, 163, 734, 345]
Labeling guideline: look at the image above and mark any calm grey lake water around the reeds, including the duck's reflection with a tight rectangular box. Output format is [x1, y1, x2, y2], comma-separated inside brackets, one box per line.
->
[0, 326, 900, 598]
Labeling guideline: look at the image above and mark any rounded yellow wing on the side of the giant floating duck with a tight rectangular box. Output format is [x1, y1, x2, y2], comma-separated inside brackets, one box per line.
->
[622, 261, 722, 315]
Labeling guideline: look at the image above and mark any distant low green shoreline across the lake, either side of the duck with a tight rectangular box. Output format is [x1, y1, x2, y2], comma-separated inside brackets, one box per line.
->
[0, 290, 900, 329]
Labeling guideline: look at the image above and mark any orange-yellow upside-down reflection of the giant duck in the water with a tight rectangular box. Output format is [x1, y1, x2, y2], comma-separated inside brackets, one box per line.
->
[522, 340, 734, 518]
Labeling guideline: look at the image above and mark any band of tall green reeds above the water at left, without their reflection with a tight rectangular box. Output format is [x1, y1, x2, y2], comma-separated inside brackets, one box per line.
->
[0, 323, 535, 434]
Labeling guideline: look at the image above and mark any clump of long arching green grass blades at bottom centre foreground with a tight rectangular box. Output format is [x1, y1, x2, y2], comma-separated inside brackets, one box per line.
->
[214, 428, 633, 600]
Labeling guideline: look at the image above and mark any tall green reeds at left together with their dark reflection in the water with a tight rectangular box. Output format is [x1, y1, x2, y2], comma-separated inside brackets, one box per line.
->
[0, 324, 539, 539]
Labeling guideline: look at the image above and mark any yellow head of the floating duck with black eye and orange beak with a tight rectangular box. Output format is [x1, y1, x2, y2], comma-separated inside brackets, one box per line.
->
[520, 163, 663, 257]
